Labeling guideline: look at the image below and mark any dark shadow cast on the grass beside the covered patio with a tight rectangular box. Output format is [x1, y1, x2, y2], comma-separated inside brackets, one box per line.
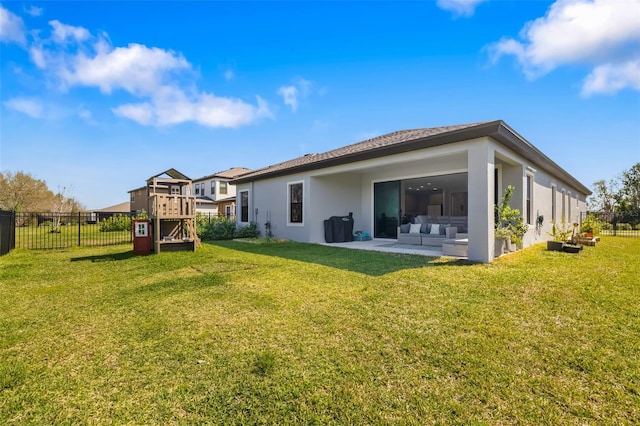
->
[207, 240, 475, 276]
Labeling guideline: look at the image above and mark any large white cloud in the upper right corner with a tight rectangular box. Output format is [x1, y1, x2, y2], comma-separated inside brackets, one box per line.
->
[490, 0, 640, 94]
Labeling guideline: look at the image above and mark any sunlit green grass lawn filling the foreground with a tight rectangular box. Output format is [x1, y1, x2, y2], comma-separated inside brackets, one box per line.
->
[0, 237, 640, 425]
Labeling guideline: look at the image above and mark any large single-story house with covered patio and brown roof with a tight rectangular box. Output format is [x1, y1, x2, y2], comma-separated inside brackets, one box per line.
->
[232, 121, 591, 262]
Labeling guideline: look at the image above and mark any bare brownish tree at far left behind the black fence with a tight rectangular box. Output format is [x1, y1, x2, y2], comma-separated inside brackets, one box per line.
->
[0, 172, 54, 211]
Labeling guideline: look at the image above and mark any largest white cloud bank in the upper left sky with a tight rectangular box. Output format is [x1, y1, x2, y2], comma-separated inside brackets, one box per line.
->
[15, 20, 272, 127]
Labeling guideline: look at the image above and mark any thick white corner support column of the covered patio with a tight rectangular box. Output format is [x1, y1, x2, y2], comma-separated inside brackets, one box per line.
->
[467, 140, 495, 263]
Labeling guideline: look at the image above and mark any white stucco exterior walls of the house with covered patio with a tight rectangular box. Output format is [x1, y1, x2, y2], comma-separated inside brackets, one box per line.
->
[238, 137, 586, 262]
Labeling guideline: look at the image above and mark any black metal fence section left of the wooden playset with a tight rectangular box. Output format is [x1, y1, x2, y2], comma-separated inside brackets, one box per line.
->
[14, 212, 133, 249]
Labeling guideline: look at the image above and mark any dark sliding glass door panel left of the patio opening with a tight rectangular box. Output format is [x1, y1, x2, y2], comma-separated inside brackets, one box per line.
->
[373, 180, 400, 238]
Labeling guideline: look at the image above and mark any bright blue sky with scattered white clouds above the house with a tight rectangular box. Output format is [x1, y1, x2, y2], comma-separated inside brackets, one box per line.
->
[0, 0, 640, 208]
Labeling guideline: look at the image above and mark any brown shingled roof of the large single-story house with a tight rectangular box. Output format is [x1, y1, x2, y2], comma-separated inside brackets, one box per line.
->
[231, 120, 591, 195]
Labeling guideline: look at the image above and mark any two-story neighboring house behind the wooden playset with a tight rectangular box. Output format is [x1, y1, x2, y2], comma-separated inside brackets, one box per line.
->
[192, 167, 251, 217]
